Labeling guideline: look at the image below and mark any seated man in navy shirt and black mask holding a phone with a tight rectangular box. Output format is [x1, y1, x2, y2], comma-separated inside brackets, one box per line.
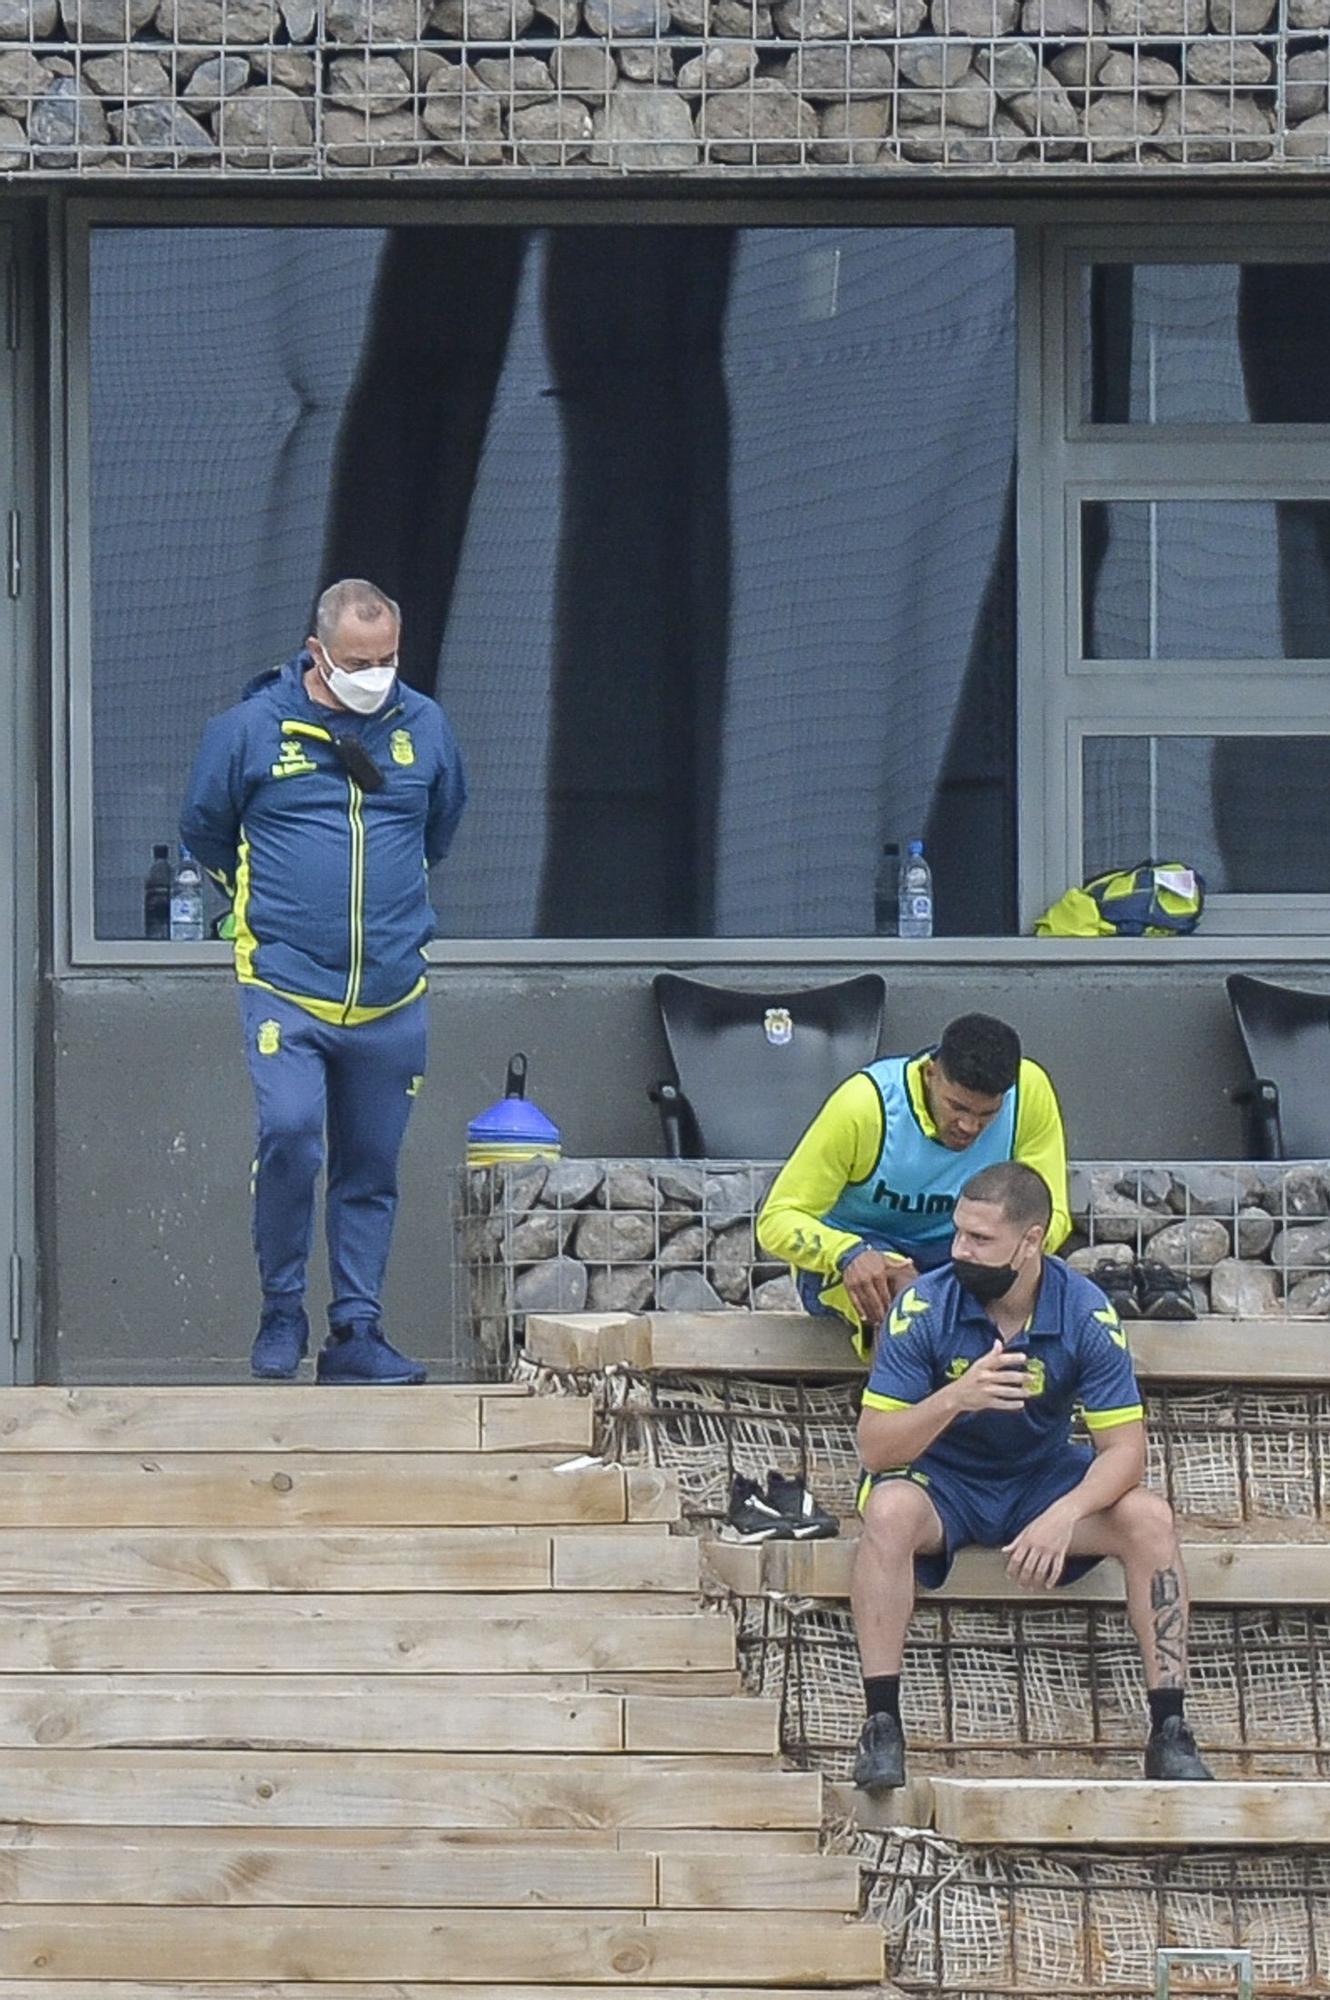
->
[850, 1160, 1210, 1792]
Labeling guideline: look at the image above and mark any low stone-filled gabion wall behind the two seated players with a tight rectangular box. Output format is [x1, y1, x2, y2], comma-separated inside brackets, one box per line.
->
[456, 1160, 1330, 1354]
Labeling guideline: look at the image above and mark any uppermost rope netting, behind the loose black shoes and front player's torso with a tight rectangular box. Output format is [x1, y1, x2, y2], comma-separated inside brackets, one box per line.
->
[516, 1360, 1330, 1540]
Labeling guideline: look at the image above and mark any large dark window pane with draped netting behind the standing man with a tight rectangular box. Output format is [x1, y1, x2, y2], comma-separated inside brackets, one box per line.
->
[92, 228, 1016, 938]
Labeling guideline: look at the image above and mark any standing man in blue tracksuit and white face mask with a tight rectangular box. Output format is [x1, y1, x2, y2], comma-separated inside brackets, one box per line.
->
[180, 578, 466, 1382]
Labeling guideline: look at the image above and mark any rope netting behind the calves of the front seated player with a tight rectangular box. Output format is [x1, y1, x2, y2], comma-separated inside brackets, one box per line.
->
[738, 1596, 1330, 1784]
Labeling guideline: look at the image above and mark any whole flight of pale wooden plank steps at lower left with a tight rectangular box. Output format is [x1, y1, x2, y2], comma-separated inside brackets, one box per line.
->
[0, 1386, 884, 2000]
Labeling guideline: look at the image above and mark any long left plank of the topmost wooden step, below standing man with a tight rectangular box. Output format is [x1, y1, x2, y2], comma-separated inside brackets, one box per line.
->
[0, 1382, 488, 1452]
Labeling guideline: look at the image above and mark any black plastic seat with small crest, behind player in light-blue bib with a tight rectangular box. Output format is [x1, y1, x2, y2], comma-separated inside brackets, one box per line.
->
[652, 972, 886, 1160]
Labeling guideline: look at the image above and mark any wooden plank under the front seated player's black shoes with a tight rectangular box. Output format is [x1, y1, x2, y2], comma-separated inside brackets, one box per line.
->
[932, 1778, 1330, 1848]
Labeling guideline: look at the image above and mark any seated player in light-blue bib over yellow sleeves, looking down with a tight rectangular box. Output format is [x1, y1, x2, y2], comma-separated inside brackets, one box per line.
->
[758, 1014, 1072, 1360]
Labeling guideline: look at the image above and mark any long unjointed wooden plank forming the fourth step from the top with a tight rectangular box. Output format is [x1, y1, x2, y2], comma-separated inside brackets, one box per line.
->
[0, 1594, 734, 1674]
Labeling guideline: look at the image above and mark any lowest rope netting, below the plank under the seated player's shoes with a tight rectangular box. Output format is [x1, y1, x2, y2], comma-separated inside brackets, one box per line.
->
[838, 1830, 1330, 2000]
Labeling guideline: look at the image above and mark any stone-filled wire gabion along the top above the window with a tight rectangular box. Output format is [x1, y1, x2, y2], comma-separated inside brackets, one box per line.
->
[0, 0, 1330, 176]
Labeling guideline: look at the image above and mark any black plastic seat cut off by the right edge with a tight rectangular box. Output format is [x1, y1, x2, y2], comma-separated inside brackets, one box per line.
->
[1224, 972, 1330, 1160]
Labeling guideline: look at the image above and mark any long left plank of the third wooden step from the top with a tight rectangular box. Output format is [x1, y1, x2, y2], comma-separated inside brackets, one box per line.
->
[0, 1528, 556, 1592]
